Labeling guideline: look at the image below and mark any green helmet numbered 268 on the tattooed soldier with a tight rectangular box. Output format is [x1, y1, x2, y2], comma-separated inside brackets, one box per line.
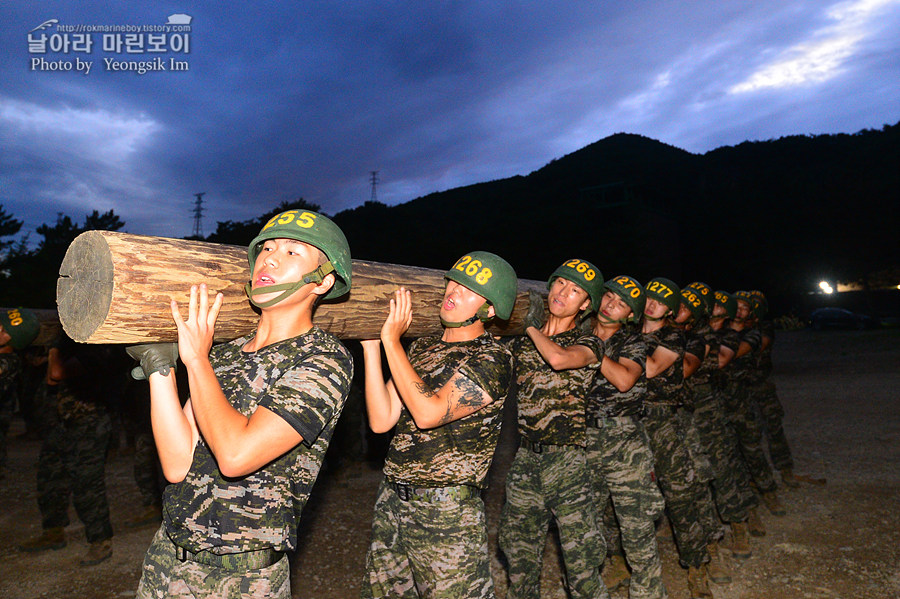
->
[444, 252, 519, 322]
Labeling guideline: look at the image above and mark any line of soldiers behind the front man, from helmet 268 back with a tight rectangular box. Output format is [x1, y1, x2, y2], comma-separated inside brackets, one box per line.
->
[361, 252, 797, 599]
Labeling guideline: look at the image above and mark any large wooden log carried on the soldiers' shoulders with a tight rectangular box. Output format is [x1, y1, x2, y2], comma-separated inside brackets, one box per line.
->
[56, 231, 547, 343]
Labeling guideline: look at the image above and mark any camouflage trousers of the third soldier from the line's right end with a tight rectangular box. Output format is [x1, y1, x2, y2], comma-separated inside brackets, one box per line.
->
[691, 386, 759, 524]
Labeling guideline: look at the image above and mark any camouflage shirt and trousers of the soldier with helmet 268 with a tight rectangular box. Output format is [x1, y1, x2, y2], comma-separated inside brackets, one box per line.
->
[360, 333, 513, 598]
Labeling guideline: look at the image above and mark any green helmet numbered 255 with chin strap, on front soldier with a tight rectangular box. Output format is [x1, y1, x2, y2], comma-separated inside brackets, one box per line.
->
[246, 209, 353, 308]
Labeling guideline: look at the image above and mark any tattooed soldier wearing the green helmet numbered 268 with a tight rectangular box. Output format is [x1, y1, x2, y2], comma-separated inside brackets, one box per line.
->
[360, 252, 517, 598]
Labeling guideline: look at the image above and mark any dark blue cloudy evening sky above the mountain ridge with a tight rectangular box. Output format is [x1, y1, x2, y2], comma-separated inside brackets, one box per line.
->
[0, 0, 900, 237]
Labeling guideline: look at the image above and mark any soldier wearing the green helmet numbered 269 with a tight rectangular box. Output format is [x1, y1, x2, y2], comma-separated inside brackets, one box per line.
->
[499, 259, 609, 599]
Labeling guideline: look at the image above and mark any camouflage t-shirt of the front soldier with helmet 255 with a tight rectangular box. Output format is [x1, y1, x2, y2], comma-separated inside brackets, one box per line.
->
[163, 327, 353, 553]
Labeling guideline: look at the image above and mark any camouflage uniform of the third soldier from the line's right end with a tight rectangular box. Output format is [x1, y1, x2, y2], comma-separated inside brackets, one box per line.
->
[685, 323, 757, 523]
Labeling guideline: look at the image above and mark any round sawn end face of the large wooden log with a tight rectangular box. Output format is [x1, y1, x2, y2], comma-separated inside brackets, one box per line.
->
[56, 231, 114, 342]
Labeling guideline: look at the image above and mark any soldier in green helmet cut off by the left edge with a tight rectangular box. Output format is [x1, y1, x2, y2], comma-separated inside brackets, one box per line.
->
[0, 308, 41, 479]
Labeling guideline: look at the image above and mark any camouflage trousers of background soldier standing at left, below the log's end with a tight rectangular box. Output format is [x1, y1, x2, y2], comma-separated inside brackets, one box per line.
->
[37, 412, 112, 543]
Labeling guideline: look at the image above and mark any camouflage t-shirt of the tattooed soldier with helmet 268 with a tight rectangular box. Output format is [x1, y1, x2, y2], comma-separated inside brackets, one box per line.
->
[384, 333, 513, 488]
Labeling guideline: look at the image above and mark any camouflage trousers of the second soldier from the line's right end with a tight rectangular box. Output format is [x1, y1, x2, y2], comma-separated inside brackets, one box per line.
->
[720, 382, 777, 493]
